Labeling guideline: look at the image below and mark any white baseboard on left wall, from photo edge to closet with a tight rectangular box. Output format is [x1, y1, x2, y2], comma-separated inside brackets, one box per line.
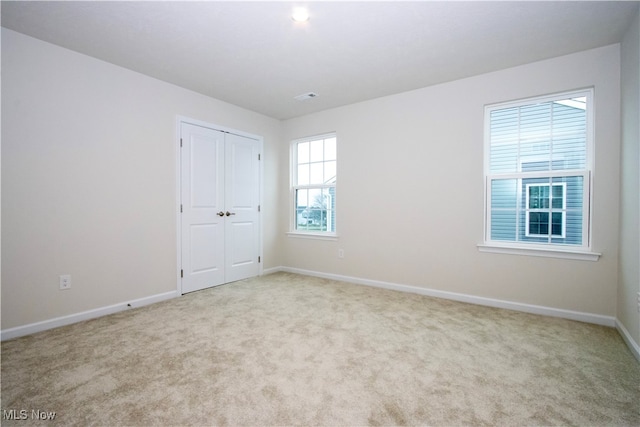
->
[0, 291, 180, 341]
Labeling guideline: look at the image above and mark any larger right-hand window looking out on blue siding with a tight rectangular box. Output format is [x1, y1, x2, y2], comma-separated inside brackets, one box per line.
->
[485, 90, 593, 252]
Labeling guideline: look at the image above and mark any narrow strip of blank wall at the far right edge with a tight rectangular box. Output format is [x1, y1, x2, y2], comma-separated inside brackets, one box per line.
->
[617, 10, 640, 348]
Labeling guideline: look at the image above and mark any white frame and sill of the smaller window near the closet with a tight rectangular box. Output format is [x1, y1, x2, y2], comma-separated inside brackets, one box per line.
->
[287, 132, 338, 240]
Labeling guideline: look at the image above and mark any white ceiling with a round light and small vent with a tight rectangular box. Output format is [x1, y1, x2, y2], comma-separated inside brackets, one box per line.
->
[1, 1, 639, 119]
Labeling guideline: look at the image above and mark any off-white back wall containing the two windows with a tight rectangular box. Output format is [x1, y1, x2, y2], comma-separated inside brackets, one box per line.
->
[280, 45, 620, 316]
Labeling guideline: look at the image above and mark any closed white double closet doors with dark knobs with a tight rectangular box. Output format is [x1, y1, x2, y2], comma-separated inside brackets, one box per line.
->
[180, 122, 260, 294]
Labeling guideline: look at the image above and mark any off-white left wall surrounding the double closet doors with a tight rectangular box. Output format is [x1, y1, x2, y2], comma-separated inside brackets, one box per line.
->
[2, 28, 282, 330]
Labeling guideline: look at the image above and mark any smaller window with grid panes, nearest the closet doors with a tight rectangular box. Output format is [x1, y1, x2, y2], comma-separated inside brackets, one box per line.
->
[291, 134, 337, 235]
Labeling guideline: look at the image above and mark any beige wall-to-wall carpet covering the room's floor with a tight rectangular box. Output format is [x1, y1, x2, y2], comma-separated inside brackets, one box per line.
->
[1, 273, 640, 426]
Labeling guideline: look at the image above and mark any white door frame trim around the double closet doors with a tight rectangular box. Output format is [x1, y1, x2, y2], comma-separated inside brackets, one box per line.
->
[175, 116, 264, 295]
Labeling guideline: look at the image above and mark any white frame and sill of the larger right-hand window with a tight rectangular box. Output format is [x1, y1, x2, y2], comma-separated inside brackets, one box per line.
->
[477, 88, 601, 261]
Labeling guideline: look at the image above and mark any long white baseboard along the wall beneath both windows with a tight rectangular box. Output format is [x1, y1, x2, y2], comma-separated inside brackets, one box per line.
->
[270, 267, 616, 327]
